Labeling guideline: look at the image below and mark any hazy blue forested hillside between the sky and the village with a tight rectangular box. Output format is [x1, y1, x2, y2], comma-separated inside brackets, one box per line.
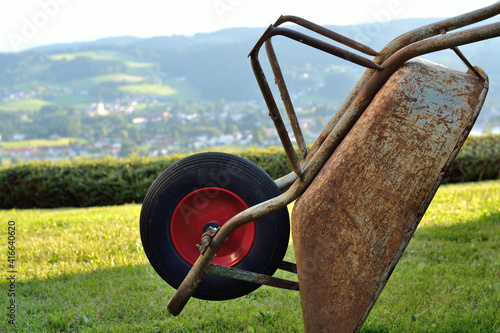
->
[0, 19, 500, 105]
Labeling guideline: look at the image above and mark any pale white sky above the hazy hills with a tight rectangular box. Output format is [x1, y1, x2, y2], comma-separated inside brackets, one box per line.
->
[0, 0, 494, 52]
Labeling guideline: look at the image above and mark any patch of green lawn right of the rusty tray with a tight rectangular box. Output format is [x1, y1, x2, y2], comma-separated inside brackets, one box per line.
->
[364, 181, 500, 332]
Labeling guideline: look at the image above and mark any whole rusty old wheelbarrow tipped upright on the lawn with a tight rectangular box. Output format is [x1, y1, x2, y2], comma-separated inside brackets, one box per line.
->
[140, 2, 500, 332]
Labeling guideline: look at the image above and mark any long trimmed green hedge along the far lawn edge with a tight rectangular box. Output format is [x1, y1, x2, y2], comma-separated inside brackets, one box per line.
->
[0, 135, 500, 209]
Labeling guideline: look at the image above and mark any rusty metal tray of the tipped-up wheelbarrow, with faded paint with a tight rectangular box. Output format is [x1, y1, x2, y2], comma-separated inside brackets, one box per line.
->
[292, 61, 486, 332]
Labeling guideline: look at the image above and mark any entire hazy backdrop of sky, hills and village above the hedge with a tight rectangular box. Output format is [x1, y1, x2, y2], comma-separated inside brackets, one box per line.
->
[0, 0, 500, 165]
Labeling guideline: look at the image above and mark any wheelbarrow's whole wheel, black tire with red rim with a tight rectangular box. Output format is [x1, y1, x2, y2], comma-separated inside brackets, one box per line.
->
[140, 153, 290, 300]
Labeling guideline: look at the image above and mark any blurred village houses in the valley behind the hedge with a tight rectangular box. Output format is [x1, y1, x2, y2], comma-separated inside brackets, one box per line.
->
[0, 84, 500, 163]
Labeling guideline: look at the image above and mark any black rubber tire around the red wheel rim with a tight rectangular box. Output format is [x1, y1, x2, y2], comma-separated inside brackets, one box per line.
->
[140, 153, 290, 300]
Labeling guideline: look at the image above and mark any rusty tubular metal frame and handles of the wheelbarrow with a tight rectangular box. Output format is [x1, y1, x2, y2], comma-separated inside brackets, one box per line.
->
[167, 2, 500, 315]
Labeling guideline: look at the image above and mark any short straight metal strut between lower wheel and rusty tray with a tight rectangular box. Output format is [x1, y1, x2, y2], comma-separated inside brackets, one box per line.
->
[207, 264, 299, 290]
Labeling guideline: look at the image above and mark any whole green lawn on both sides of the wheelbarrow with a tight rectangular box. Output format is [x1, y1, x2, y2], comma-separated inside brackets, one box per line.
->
[0, 181, 500, 332]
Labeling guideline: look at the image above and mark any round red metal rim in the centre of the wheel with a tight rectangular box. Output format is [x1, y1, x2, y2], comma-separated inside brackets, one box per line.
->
[170, 187, 255, 266]
